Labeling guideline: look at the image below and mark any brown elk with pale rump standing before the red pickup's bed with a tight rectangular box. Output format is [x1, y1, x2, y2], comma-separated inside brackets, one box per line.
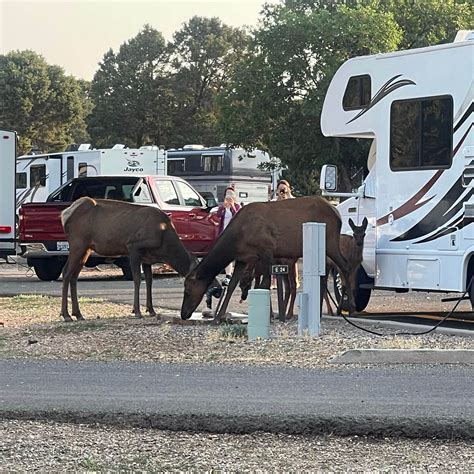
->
[61, 197, 197, 321]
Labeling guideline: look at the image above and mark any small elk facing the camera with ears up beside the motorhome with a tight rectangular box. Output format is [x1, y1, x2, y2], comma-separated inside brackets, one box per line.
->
[322, 217, 368, 316]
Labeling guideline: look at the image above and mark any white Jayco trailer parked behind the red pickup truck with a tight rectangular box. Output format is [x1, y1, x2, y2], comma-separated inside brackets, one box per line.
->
[16, 144, 166, 207]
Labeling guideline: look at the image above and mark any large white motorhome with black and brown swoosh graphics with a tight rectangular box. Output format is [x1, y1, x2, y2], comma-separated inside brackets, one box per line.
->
[321, 32, 474, 310]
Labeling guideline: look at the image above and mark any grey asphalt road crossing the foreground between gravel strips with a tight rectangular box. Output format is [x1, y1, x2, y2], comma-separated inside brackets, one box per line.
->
[0, 360, 474, 438]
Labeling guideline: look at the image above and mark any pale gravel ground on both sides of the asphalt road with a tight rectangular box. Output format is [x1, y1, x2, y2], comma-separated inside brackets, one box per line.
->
[0, 268, 474, 473]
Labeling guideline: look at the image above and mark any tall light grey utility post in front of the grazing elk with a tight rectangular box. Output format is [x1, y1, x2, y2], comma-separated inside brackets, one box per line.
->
[298, 222, 326, 336]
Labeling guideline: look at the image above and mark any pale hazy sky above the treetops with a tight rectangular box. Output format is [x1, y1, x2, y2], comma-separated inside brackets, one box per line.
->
[0, 0, 278, 80]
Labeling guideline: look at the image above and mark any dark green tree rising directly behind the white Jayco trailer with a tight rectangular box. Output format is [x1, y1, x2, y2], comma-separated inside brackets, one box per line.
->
[88, 25, 170, 147]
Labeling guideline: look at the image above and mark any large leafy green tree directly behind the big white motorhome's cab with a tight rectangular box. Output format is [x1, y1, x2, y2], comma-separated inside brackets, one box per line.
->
[219, 0, 472, 194]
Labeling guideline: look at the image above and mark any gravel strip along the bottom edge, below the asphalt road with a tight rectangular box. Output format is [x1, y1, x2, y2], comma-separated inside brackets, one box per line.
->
[0, 421, 474, 473]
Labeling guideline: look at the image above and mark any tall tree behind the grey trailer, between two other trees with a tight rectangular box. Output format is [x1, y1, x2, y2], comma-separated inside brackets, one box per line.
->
[170, 16, 248, 146]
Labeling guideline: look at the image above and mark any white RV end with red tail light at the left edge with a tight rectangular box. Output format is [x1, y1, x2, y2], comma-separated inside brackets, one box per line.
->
[0, 130, 16, 258]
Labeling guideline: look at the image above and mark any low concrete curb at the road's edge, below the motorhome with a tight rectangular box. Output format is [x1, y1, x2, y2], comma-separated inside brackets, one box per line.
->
[331, 349, 474, 364]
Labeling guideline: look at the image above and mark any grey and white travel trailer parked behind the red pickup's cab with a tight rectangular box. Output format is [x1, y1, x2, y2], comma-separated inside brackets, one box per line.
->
[167, 145, 274, 204]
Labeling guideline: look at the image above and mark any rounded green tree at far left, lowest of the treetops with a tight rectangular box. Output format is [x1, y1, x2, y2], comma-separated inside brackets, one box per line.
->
[0, 51, 87, 154]
